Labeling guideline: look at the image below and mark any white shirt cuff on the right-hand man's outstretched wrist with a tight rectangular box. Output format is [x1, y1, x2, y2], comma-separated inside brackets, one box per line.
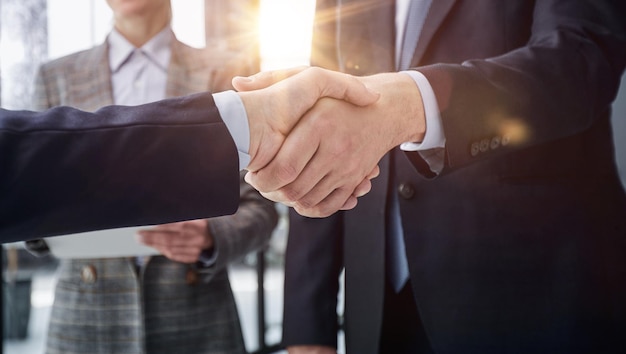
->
[400, 70, 446, 151]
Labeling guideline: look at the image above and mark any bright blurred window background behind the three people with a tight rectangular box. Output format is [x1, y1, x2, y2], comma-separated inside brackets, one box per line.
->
[0, 0, 626, 354]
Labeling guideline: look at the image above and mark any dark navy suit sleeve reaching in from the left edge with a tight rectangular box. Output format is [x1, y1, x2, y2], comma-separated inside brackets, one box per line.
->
[0, 94, 239, 242]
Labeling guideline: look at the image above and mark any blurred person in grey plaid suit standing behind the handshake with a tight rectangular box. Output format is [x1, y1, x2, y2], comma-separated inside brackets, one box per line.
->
[28, 0, 277, 353]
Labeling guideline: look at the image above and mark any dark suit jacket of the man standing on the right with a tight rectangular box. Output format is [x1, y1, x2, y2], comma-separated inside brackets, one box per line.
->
[284, 0, 626, 354]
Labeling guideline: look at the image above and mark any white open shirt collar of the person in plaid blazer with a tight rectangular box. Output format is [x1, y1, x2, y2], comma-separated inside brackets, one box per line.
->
[107, 26, 174, 73]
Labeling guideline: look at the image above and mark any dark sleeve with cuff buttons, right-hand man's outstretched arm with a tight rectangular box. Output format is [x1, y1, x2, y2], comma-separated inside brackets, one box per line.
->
[416, 0, 626, 174]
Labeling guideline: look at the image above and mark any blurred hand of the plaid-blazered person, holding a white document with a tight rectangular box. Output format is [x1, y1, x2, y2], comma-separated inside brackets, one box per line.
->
[137, 219, 213, 263]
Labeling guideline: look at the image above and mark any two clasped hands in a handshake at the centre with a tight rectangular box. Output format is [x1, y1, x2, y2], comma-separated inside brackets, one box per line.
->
[233, 67, 425, 217]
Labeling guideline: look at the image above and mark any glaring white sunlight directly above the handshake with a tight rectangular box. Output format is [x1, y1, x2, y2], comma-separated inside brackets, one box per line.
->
[259, 0, 315, 70]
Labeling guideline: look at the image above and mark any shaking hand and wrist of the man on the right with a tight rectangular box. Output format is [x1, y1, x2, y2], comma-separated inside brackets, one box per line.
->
[234, 73, 425, 217]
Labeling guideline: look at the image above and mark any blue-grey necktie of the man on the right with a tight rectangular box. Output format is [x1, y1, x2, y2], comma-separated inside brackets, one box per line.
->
[386, 0, 432, 293]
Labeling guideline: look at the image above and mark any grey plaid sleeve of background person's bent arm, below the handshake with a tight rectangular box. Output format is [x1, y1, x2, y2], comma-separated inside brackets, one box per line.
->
[200, 172, 278, 282]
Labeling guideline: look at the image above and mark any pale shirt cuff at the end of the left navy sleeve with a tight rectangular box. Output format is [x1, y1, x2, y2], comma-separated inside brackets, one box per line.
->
[213, 90, 250, 170]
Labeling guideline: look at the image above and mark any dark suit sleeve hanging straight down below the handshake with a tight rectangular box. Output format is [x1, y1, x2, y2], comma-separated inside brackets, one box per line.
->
[283, 210, 343, 347]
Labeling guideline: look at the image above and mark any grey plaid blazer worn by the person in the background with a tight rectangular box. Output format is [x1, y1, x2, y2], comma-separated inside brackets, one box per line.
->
[30, 32, 277, 354]
